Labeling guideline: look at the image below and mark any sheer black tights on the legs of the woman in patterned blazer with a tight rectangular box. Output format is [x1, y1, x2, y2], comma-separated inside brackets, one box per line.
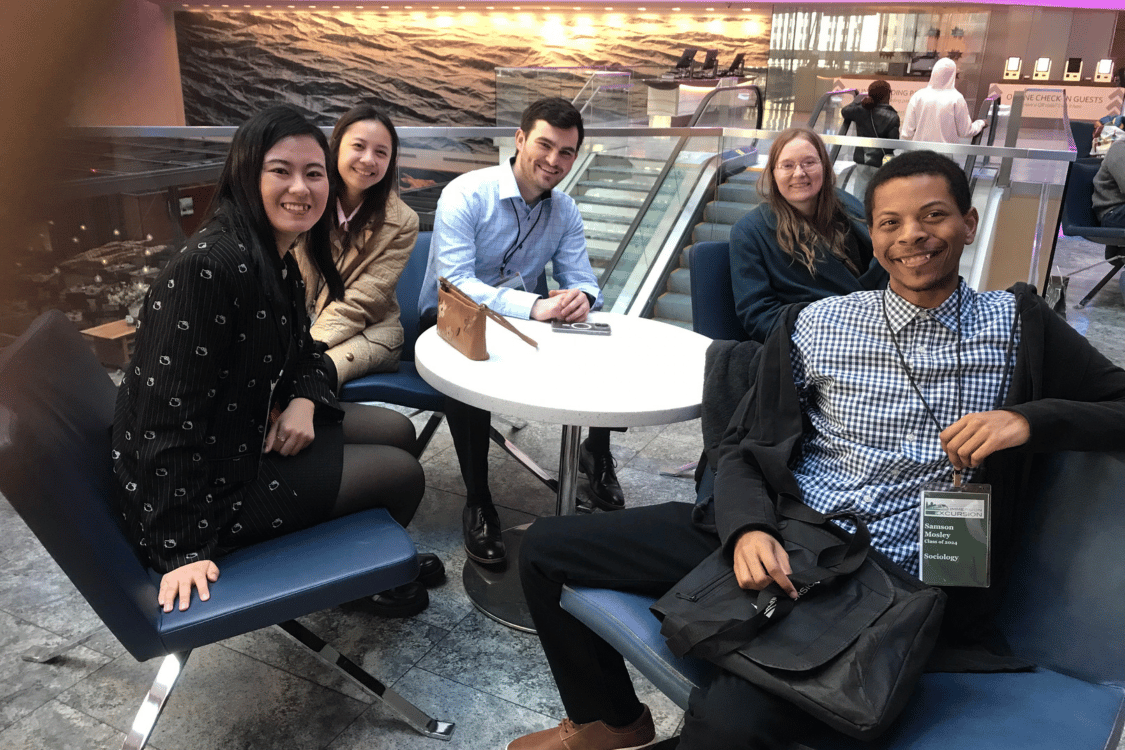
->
[330, 404, 425, 526]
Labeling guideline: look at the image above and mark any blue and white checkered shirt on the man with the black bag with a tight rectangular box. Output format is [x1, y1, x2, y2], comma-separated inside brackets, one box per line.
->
[792, 281, 1019, 575]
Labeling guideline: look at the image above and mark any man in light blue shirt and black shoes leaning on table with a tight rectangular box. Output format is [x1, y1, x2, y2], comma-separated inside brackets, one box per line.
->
[419, 98, 624, 562]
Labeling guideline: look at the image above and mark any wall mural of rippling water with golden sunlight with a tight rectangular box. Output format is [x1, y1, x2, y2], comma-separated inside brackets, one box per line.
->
[176, 11, 770, 127]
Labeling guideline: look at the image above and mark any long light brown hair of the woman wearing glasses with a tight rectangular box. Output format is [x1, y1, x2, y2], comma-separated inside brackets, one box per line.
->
[758, 127, 860, 275]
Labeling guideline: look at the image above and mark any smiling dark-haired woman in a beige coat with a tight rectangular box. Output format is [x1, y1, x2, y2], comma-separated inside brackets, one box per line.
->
[300, 105, 419, 389]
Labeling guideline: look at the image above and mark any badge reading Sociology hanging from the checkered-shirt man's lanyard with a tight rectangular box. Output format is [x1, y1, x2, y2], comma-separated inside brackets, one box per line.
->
[918, 482, 992, 588]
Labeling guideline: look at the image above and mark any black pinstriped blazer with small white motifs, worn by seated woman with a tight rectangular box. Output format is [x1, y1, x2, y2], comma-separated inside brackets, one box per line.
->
[113, 222, 341, 572]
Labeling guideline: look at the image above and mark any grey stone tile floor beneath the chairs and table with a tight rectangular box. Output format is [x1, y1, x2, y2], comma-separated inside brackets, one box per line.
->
[0, 238, 1125, 750]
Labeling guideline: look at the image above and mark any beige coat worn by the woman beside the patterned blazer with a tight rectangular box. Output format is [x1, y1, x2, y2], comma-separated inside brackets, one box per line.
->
[298, 193, 419, 385]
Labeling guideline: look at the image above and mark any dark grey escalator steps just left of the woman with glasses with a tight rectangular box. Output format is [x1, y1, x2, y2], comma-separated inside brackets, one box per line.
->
[653, 170, 762, 328]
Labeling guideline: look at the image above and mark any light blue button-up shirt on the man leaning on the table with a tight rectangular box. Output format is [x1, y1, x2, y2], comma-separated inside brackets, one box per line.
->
[419, 161, 602, 319]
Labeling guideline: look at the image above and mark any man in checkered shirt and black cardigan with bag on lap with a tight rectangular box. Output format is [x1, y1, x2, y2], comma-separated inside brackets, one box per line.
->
[509, 152, 1125, 750]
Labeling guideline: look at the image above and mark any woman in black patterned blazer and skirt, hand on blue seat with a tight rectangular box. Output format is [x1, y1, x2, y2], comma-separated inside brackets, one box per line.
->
[113, 106, 441, 615]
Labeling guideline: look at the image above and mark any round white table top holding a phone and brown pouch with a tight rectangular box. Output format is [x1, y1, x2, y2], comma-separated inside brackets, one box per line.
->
[414, 313, 711, 427]
